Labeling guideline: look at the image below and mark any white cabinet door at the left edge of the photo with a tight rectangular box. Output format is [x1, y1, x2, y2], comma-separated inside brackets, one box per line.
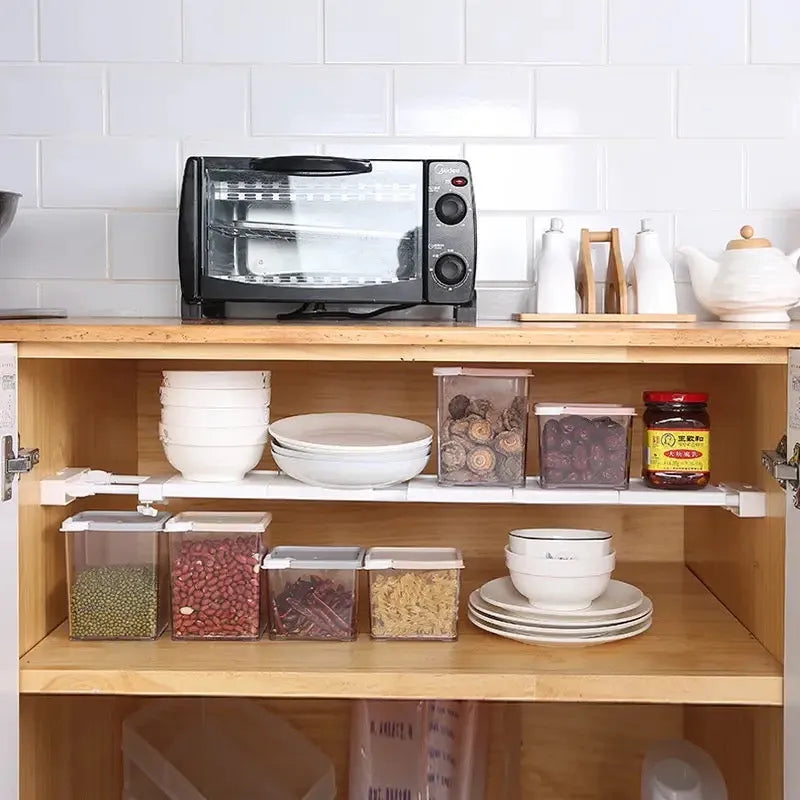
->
[0, 344, 19, 800]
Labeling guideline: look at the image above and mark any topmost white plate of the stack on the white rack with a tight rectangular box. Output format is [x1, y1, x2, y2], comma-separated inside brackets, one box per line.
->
[269, 414, 433, 455]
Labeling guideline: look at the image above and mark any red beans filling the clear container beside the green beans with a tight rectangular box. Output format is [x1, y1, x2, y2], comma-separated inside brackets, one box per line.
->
[171, 536, 263, 639]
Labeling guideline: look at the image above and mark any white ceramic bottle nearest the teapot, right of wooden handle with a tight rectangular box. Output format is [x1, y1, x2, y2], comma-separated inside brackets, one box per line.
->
[626, 219, 678, 314]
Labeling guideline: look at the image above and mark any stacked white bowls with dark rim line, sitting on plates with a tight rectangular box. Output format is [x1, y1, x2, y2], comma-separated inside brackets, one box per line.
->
[505, 528, 616, 611]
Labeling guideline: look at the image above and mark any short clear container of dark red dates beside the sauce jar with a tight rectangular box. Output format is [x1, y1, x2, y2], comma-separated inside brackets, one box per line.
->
[534, 403, 636, 489]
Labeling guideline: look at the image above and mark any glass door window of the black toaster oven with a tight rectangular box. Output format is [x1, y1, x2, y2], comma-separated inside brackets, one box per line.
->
[206, 161, 424, 289]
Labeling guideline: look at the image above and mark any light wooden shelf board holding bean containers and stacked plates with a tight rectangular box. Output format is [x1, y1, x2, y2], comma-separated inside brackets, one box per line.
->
[20, 563, 783, 706]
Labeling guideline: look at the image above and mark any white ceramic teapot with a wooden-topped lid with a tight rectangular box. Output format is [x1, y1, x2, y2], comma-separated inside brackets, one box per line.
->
[678, 225, 800, 322]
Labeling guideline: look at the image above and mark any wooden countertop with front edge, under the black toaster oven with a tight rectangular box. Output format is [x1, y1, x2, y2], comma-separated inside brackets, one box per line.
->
[0, 318, 800, 363]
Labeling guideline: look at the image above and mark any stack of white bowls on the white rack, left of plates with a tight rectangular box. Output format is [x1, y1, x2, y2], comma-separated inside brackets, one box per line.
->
[159, 370, 270, 482]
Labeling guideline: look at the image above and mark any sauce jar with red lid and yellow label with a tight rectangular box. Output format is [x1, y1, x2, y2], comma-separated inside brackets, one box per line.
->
[642, 392, 711, 489]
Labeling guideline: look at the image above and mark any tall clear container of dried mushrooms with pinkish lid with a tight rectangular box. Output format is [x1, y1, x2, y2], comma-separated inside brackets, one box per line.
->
[433, 367, 531, 486]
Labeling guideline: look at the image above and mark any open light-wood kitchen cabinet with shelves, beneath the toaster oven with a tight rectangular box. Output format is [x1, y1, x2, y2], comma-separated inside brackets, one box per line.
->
[0, 320, 800, 800]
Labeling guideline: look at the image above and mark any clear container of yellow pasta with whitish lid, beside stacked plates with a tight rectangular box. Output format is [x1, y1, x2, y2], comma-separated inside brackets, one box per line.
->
[364, 547, 464, 640]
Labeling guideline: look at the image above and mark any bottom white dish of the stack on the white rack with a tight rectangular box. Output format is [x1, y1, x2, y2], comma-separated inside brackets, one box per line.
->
[272, 450, 430, 489]
